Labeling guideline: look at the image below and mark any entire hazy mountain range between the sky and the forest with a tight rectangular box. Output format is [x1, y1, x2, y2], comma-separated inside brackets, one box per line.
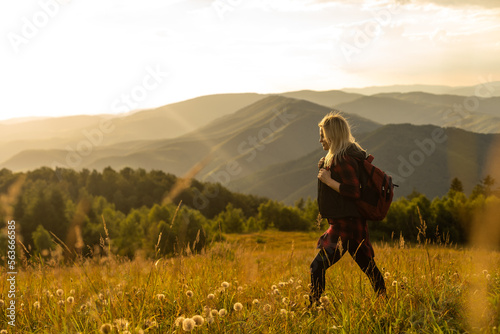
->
[0, 86, 500, 203]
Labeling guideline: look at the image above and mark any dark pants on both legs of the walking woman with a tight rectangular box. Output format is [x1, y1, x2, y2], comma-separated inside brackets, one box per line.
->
[311, 244, 385, 302]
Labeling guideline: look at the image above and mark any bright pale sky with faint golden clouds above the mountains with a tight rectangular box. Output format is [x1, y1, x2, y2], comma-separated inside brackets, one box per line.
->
[0, 0, 500, 120]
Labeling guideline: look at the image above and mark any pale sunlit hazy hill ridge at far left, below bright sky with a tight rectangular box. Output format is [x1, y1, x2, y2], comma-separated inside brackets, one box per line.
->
[0, 93, 266, 161]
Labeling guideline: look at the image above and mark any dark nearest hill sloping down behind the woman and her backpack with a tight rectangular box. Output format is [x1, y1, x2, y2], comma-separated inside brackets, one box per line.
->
[229, 124, 500, 204]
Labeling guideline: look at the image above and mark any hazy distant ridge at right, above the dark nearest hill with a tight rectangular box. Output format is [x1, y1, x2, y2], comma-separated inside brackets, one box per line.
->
[291, 91, 500, 133]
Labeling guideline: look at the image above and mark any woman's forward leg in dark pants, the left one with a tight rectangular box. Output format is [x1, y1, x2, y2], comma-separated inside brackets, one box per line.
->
[309, 249, 345, 304]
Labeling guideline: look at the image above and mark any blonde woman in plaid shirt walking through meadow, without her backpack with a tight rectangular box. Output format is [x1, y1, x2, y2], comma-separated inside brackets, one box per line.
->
[310, 113, 385, 305]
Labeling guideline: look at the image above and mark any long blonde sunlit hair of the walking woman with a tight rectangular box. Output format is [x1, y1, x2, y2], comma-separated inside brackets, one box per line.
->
[318, 110, 363, 166]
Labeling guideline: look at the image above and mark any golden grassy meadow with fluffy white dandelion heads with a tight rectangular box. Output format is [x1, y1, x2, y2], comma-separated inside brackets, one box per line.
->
[0, 231, 500, 333]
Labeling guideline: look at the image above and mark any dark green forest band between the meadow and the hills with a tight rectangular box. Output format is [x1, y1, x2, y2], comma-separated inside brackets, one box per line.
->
[0, 167, 500, 258]
